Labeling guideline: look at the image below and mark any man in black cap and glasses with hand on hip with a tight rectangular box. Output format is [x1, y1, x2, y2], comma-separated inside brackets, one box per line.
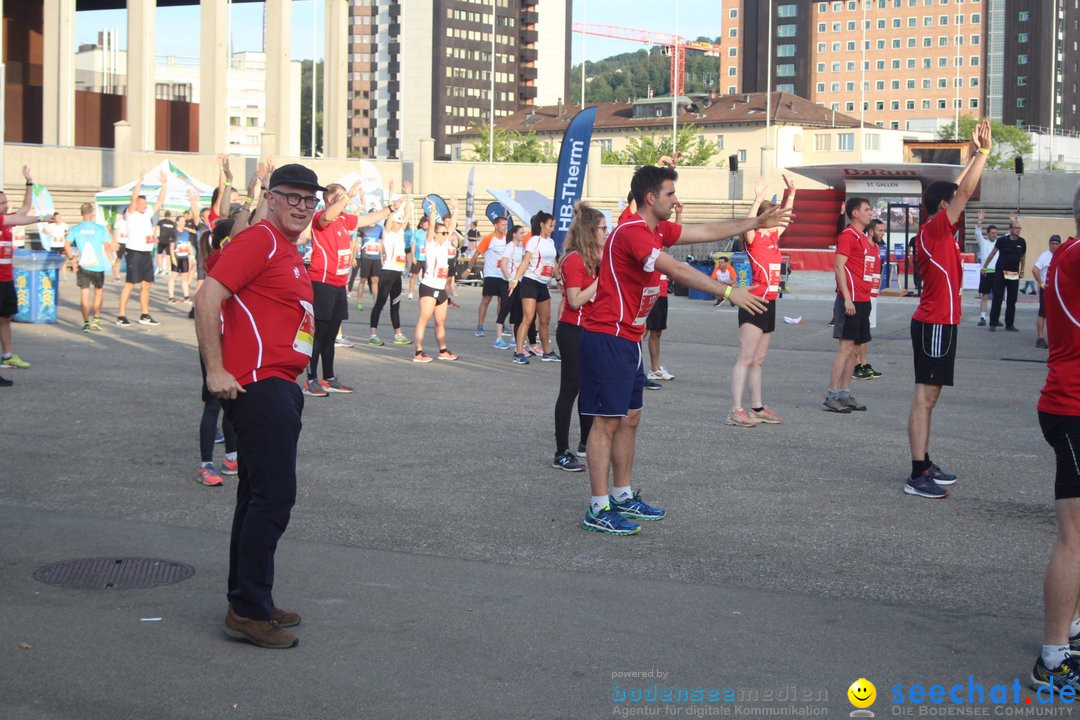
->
[194, 164, 324, 648]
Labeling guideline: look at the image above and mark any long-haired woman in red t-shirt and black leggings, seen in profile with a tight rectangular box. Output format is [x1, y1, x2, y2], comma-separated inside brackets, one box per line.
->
[551, 203, 607, 473]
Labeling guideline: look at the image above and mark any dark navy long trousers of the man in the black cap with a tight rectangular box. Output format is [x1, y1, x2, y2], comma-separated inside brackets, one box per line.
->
[224, 378, 303, 620]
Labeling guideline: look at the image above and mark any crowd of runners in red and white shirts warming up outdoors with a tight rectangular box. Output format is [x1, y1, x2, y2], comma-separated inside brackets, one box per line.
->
[6, 122, 1080, 689]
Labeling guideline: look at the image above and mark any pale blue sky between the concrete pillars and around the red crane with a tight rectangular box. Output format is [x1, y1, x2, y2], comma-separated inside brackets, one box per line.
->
[76, 0, 723, 64]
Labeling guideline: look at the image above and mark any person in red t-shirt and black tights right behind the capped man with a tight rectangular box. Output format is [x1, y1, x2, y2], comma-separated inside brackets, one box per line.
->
[303, 180, 403, 397]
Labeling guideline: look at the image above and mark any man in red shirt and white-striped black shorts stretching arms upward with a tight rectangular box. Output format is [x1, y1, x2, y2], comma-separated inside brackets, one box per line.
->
[904, 120, 993, 498]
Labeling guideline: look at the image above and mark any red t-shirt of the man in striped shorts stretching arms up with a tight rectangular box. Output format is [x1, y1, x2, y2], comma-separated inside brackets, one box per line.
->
[912, 210, 963, 325]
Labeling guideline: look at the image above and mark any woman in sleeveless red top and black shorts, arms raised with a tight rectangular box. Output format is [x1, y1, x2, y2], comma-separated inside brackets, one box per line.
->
[724, 177, 795, 427]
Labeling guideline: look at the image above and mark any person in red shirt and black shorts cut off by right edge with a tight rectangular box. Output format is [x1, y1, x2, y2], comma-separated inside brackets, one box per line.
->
[1030, 185, 1080, 692]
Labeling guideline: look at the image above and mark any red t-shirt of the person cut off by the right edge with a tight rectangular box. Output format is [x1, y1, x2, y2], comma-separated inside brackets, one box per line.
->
[1036, 237, 1080, 417]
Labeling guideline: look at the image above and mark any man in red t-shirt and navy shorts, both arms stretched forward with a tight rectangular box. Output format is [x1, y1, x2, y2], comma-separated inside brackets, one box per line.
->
[578, 166, 791, 535]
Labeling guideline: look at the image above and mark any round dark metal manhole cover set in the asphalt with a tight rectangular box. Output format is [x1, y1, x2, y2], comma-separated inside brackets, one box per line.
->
[33, 557, 195, 590]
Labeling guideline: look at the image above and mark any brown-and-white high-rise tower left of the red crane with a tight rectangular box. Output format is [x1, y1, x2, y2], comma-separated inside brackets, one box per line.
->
[349, 0, 570, 160]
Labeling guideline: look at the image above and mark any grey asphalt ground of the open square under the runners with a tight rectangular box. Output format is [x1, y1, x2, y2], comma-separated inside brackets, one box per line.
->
[0, 267, 1055, 720]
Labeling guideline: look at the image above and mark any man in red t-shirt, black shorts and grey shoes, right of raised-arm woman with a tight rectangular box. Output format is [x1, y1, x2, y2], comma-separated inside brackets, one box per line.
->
[823, 198, 881, 412]
